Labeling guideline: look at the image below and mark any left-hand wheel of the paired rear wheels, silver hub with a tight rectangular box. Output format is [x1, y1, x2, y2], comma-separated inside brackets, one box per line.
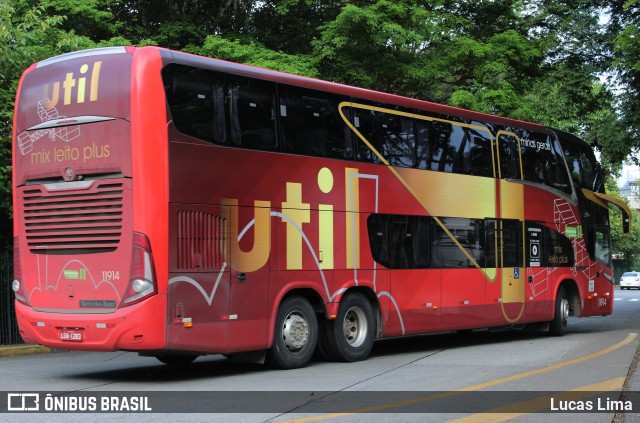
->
[267, 296, 318, 369]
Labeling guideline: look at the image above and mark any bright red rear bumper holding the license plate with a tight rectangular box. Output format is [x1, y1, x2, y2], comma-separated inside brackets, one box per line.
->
[15, 295, 166, 351]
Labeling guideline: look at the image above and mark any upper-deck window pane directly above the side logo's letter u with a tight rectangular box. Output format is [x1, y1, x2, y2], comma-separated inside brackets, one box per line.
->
[229, 78, 277, 150]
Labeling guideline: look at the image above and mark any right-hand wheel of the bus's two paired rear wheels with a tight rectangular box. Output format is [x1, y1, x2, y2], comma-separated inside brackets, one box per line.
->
[318, 292, 376, 362]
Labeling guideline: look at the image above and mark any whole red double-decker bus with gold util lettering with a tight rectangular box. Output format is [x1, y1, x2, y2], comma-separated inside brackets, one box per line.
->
[13, 47, 629, 368]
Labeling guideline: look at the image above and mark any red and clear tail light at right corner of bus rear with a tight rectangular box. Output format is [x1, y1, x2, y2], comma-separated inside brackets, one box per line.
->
[120, 232, 158, 307]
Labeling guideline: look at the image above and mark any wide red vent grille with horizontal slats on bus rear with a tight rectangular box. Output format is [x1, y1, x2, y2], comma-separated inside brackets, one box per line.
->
[24, 183, 123, 254]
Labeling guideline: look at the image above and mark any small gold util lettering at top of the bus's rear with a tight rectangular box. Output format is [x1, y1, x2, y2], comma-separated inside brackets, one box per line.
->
[42, 61, 102, 109]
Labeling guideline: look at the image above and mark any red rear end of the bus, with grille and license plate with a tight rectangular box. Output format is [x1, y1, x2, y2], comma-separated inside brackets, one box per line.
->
[13, 48, 166, 351]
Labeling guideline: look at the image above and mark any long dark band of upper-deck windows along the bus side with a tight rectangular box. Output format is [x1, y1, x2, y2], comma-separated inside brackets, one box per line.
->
[163, 64, 572, 194]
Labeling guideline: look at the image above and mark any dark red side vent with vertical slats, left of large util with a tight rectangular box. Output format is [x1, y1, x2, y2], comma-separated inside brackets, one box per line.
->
[178, 210, 225, 270]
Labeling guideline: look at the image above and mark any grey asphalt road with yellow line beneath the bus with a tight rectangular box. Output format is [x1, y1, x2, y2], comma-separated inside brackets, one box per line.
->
[0, 290, 640, 422]
